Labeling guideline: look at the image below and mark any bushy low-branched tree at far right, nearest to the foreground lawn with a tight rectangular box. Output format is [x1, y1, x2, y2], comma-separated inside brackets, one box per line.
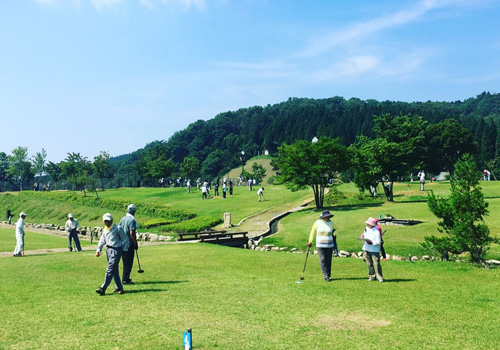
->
[423, 155, 496, 267]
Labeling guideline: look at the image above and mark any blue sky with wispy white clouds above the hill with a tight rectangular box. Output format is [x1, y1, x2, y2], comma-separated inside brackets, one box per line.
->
[0, 0, 500, 162]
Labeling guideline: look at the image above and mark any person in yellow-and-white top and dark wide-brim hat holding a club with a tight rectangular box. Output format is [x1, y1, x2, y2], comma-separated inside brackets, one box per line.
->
[307, 210, 338, 282]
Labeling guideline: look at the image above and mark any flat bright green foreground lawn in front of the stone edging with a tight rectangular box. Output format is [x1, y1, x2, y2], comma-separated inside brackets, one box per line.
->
[0, 244, 500, 349]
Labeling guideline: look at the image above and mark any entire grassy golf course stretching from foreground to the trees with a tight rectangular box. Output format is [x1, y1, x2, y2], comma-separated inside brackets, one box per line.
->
[0, 181, 500, 350]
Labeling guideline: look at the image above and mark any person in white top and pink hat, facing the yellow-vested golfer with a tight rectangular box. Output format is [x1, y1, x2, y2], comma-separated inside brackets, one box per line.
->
[361, 218, 384, 282]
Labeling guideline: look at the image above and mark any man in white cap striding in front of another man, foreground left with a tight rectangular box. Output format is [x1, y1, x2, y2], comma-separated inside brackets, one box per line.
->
[95, 213, 128, 295]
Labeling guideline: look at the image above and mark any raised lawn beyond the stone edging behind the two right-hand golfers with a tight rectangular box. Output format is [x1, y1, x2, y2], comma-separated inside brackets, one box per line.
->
[263, 182, 500, 260]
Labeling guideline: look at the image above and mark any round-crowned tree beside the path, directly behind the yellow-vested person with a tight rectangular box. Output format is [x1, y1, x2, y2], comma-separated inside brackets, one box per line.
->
[272, 137, 350, 208]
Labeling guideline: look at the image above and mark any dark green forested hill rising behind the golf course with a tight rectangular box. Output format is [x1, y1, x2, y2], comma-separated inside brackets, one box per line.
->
[114, 92, 500, 180]
